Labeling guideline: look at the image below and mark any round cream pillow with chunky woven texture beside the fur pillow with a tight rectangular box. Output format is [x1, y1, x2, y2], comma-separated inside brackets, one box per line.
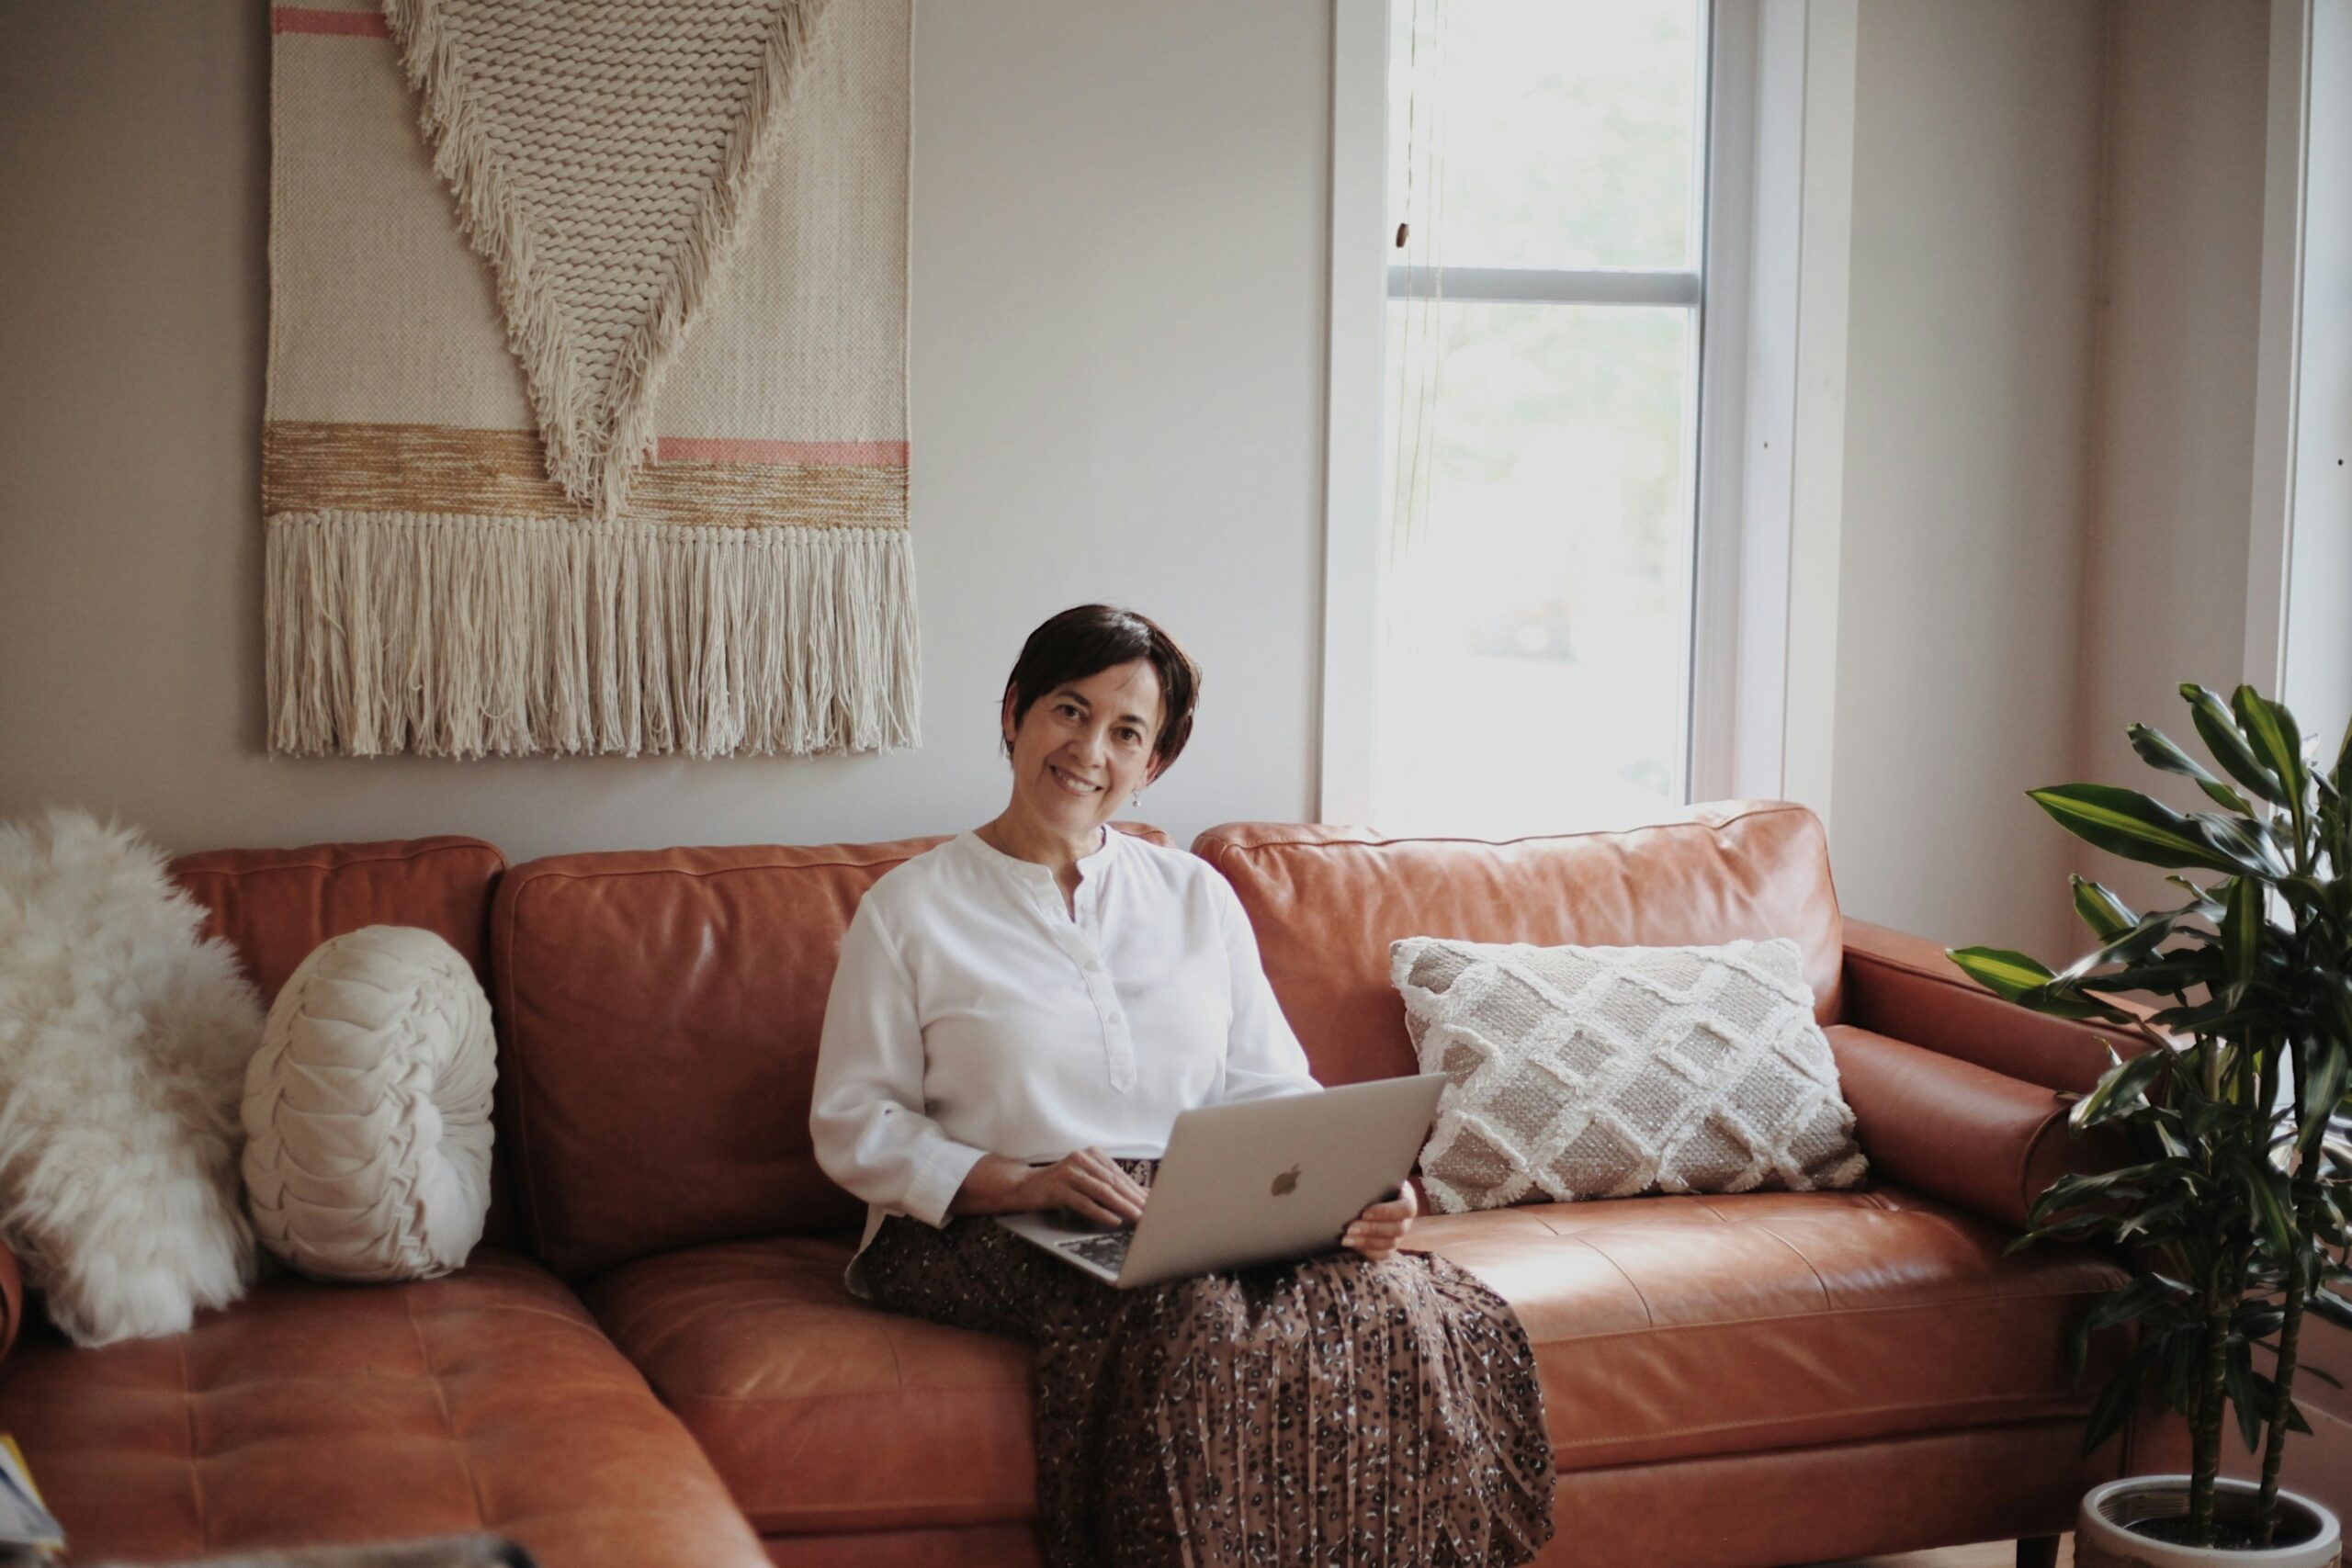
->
[244, 926, 499, 1281]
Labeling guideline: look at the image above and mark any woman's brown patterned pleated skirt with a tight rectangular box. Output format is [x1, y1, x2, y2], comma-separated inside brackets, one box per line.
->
[861, 1164, 1553, 1568]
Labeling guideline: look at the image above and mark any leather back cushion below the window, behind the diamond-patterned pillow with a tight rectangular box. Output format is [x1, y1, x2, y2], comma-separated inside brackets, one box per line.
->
[1193, 802, 1844, 1084]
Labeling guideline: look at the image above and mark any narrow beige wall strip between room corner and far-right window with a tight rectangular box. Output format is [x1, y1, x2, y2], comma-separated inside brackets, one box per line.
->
[2079, 0, 2269, 911]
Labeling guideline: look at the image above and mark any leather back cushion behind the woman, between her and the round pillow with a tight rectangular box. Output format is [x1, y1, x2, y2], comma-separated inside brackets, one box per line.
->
[492, 829, 1164, 1279]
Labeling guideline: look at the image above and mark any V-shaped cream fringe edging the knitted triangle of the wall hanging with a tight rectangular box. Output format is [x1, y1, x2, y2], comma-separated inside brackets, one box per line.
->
[383, 0, 831, 520]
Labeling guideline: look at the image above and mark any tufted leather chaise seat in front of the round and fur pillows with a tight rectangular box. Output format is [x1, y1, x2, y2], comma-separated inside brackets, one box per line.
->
[0, 1253, 767, 1568]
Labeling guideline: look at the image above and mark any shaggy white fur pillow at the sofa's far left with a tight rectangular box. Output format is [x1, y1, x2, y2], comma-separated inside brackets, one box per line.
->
[0, 811, 261, 1345]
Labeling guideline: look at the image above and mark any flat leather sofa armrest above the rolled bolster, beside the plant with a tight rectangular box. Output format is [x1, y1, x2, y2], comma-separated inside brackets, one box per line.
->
[1839, 919, 2147, 1093]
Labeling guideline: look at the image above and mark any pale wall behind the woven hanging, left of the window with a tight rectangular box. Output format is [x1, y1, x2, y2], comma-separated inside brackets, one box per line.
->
[0, 0, 1329, 861]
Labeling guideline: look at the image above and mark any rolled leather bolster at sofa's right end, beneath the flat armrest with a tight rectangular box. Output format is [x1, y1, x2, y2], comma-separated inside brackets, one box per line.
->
[1827, 1025, 2109, 1229]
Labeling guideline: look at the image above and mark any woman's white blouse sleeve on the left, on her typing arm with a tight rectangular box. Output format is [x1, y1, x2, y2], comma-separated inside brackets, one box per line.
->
[809, 905, 986, 1224]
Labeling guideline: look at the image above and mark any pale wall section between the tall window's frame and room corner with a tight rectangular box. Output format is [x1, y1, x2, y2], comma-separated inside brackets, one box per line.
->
[1830, 0, 2100, 947]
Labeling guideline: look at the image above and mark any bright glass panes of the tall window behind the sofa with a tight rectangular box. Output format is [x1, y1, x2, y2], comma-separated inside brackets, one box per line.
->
[1363, 0, 1713, 837]
